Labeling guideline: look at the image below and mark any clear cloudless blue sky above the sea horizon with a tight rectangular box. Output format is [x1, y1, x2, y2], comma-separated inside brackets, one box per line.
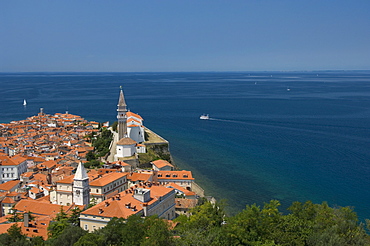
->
[0, 0, 370, 72]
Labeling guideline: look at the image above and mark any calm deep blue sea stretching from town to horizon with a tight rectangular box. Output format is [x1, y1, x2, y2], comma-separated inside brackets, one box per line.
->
[0, 71, 370, 219]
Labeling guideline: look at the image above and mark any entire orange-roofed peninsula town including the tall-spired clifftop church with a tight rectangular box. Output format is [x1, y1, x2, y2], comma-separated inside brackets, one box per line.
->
[0, 88, 204, 240]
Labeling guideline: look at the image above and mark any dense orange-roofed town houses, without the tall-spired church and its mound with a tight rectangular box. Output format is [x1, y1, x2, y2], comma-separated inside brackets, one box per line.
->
[0, 111, 202, 239]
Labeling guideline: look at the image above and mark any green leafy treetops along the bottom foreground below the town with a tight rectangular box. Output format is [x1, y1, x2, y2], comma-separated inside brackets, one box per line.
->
[0, 200, 370, 246]
